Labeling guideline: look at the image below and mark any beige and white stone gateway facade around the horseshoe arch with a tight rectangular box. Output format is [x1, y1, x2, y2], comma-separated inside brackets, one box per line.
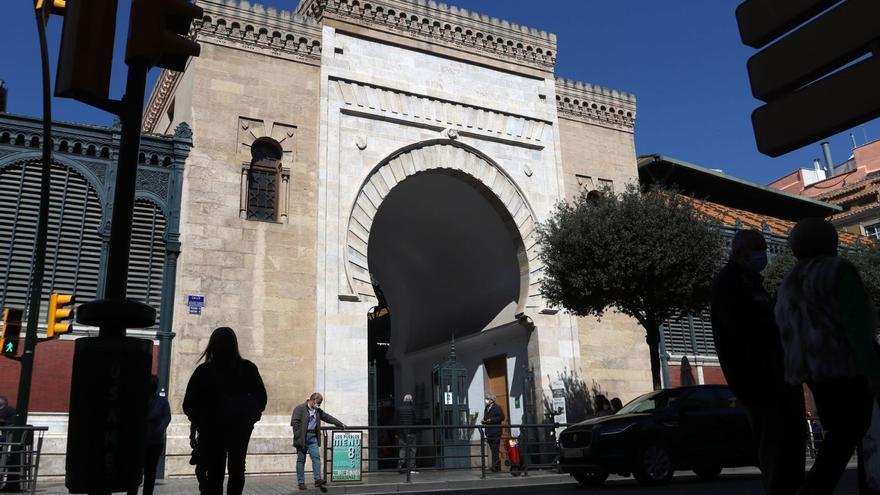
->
[138, 0, 650, 474]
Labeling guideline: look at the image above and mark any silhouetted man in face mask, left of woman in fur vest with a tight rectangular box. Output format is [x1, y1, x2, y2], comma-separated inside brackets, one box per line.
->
[711, 230, 805, 495]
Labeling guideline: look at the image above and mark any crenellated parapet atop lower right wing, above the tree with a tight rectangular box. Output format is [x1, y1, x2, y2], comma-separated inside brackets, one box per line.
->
[556, 78, 636, 132]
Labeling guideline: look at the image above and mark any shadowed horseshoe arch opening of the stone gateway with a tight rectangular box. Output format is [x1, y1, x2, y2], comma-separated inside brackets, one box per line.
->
[368, 169, 525, 469]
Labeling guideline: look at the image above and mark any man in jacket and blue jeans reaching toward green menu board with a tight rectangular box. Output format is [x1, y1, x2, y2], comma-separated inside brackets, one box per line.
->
[290, 392, 345, 491]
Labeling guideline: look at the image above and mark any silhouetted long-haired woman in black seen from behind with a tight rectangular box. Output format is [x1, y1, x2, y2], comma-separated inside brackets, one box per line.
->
[183, 327, 266, 495]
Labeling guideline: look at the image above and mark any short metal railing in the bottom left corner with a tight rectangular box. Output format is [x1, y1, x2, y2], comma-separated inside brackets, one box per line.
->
[0, 426, 49, 494]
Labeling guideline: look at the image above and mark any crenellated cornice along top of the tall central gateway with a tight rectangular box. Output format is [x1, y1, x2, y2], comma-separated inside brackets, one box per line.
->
[297, 0, 556, 72]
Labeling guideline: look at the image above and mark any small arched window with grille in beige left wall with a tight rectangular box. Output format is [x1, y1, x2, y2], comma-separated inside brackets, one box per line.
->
[247, 137, 282, 222]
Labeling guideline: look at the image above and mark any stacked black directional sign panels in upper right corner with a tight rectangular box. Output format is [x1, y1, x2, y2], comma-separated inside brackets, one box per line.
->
[736, 0, 880, 156]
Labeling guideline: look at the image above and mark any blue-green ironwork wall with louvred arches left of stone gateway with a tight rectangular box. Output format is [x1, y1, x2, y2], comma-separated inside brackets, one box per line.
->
[0, 113, 192, 400]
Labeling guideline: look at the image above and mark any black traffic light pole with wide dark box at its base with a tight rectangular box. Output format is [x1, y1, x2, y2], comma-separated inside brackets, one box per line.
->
[65, 59, 156, 494]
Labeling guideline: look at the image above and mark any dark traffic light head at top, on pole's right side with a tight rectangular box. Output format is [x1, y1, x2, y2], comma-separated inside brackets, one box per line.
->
[125, 0, 204, 72]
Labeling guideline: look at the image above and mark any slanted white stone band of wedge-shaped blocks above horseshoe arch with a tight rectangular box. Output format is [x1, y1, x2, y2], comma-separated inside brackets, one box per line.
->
[329, 79, 552, 146]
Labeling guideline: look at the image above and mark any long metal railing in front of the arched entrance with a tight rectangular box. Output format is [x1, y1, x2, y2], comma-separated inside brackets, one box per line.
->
[321, 423, 569, 482]
